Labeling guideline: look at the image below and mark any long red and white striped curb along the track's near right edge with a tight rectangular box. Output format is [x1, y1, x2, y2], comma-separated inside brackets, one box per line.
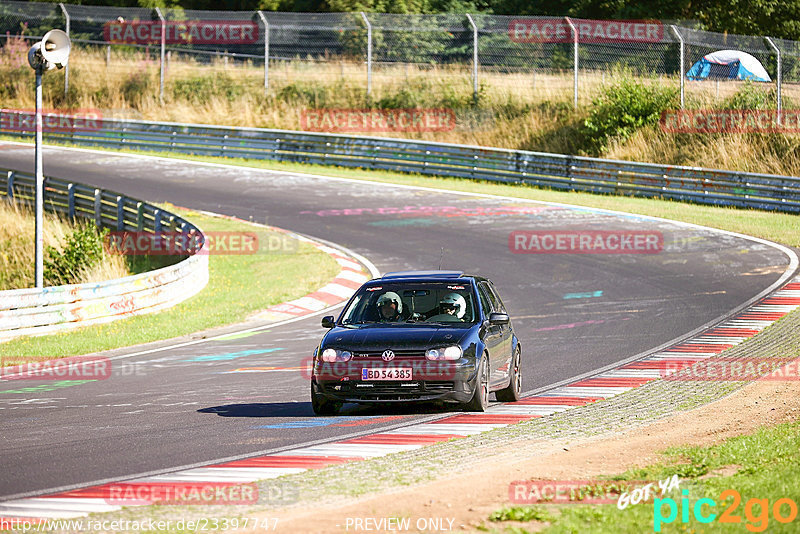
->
[0, 278, 800, 522]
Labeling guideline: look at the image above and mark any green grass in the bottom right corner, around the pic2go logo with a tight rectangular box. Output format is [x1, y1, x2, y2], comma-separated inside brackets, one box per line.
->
[482, 421, 800, 534]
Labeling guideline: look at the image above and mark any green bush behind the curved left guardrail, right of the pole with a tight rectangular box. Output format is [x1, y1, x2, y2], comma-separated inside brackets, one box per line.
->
[44, 225, 108, 286]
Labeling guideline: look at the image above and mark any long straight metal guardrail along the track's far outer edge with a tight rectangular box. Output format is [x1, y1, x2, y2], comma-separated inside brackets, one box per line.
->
[0, 110, 800, 213]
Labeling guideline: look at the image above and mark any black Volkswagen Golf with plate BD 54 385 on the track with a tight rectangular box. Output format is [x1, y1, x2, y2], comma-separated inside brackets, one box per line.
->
[311, 271, 522, 415]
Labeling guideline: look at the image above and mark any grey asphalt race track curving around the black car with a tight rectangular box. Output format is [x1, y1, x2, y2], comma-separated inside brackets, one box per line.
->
[0, 144, 789, 500]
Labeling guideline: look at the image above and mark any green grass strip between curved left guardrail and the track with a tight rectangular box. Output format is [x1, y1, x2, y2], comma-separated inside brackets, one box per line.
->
[2, 206, 339, 361]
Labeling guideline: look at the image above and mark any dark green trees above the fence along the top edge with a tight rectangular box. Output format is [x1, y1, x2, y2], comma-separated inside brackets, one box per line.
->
[29, 0, 800, 40]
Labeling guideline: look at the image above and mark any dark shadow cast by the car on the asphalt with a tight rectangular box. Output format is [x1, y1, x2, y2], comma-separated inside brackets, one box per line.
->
[197, 402, 461, 418]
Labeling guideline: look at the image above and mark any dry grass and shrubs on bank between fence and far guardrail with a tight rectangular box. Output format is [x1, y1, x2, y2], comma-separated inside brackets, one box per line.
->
[0, 38, 800, 176]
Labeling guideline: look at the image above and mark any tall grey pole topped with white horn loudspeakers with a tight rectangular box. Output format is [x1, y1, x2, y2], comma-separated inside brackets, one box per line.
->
[28, 30, 70, 289]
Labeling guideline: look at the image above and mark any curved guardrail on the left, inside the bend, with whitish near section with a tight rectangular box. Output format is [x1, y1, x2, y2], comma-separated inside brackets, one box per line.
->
[0, 170, 208, 342]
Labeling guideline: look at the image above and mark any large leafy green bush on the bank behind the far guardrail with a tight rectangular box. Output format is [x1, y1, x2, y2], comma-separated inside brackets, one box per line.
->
[582, 78, 678, 155]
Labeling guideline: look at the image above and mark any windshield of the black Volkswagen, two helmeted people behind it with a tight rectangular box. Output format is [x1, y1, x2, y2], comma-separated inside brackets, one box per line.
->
[342, 281, 477, 327]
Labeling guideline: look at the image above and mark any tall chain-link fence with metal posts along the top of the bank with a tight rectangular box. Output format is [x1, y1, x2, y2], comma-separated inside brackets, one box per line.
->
[0, 1, 800, 112]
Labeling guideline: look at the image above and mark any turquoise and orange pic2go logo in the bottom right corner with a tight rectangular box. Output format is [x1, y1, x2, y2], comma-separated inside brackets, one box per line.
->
[653, 489, 797, 532]
